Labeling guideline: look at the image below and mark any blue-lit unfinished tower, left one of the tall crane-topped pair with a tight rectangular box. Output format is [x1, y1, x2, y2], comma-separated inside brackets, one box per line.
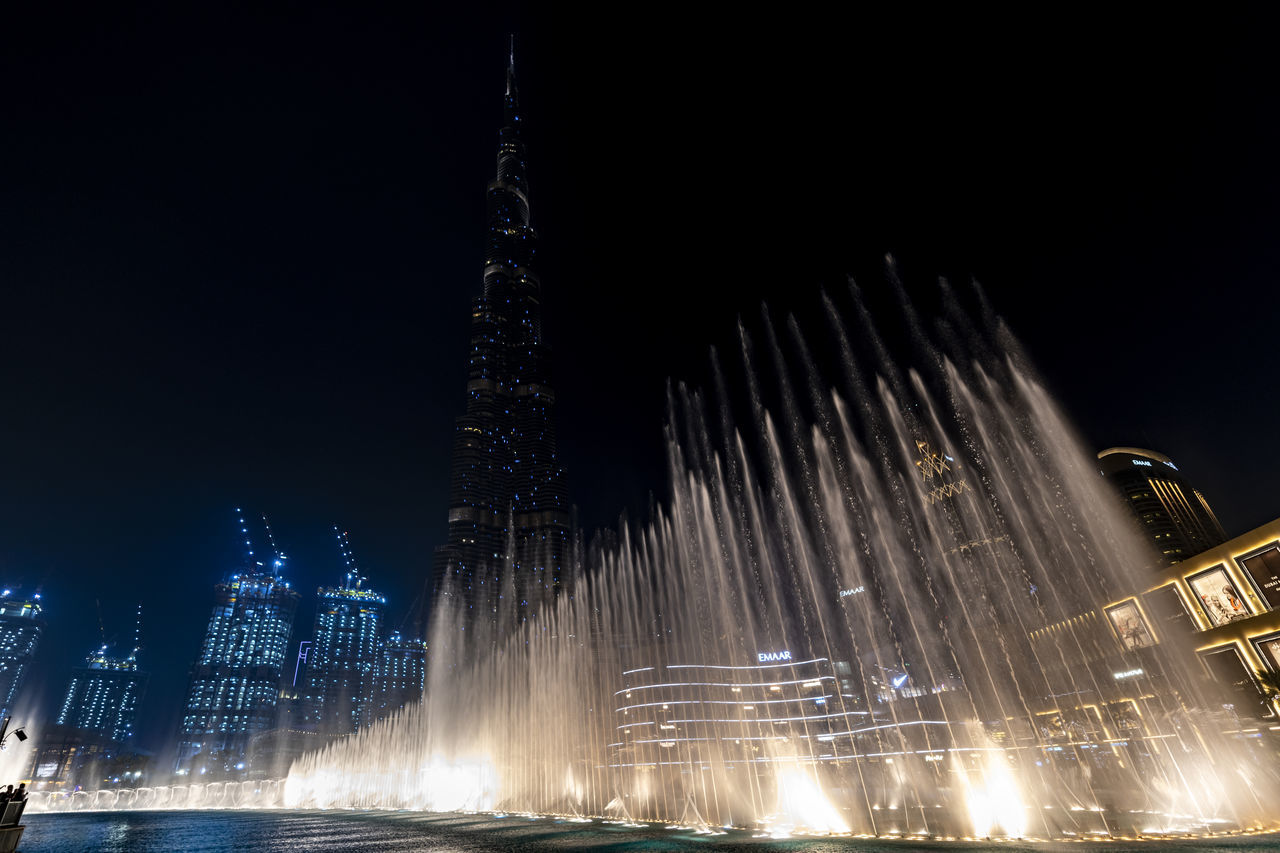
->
[177, 507, 298, 776]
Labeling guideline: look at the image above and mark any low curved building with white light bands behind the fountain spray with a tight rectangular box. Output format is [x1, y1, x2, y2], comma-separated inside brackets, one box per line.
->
[607, 649, 951, 822]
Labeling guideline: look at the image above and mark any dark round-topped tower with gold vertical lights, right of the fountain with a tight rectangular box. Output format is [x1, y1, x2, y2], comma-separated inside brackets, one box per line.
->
[1098, 447, 1226, 565]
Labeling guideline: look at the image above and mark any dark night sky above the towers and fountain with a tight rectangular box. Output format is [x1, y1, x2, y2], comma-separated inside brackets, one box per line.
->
[0, 4, 1280, 748]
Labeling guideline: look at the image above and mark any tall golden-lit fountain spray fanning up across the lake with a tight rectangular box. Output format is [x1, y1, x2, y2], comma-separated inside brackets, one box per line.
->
[283, 275, 1277, 838]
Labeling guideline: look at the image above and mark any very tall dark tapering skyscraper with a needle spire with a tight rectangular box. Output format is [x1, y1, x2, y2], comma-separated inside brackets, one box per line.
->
[434, 39, 570, 620]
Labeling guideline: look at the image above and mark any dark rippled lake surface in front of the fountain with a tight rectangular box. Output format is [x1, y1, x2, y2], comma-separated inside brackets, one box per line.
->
[22, 811, 1280, 853]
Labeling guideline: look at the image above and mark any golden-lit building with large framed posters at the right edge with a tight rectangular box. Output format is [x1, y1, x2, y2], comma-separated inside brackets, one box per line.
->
[1142, 519, 1280, 716]
